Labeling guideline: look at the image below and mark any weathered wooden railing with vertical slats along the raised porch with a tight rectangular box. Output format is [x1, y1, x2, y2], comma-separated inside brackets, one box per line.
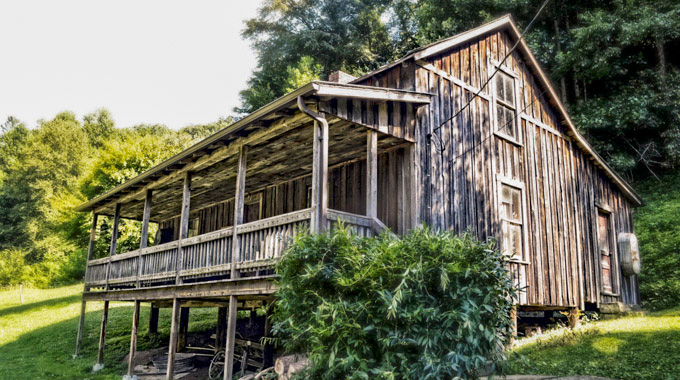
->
[85, 208, 376, 288]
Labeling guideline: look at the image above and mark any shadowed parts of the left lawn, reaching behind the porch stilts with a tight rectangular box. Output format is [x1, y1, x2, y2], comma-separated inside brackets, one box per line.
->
[0, 302, 216, 380]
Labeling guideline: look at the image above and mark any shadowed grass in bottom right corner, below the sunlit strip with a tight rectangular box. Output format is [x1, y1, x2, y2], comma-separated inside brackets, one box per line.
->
[511, 320, 680, 379]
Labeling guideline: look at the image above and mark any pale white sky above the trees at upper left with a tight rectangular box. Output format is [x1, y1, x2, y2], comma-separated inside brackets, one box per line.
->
[0, 0, 261, 129]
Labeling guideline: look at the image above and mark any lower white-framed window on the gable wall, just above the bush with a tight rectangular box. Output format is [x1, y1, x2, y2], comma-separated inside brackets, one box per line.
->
[500, 182, 524, 261]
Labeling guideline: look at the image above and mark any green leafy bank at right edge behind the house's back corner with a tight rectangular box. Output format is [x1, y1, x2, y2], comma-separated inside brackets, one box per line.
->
[635, 174, 680, 309]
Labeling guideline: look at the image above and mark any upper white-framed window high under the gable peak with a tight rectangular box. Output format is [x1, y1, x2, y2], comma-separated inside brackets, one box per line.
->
[494, 71, 520, 143]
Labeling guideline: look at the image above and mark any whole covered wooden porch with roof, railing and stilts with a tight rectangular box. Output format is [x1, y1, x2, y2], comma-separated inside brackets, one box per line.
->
[76, 82, 430, 379]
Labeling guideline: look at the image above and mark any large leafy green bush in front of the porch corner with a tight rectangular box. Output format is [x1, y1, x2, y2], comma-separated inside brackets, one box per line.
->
[273, 226, 515, 379]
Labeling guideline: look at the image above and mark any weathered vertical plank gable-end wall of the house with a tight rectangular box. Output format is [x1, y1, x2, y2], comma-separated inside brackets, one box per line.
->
[357, 31, 639, 306]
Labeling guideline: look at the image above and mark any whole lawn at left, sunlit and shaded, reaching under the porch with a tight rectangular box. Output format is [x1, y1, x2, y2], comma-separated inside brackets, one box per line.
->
[0, 284, 217, 380]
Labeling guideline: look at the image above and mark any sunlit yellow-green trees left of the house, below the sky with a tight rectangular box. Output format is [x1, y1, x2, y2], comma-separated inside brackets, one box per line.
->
[0, 109, 231, 287]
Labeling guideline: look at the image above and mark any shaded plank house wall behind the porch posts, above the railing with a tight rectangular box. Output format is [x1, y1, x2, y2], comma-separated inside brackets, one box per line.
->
[160, 147, 408, 240]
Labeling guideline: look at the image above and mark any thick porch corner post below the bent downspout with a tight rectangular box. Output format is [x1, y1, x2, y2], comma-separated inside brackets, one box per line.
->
[310, 119, 328, 233]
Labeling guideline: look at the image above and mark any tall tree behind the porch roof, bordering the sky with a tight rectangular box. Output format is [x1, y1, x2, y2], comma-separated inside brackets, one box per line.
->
[235, 0, 394, 113]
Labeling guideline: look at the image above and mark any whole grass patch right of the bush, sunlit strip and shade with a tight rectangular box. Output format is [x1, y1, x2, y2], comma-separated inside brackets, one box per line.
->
[510, 308, 680, 380]
